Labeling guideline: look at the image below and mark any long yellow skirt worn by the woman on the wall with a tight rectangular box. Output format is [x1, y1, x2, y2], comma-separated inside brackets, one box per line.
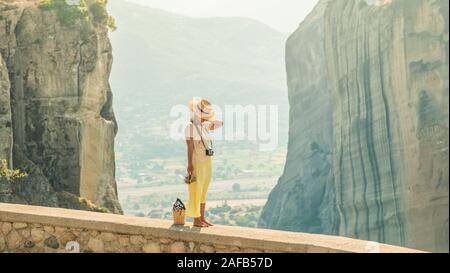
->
[186, 158, 212, 218]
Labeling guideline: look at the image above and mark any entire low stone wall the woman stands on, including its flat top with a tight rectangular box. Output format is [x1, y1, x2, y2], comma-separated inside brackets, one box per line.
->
[0, 203, 424, 253]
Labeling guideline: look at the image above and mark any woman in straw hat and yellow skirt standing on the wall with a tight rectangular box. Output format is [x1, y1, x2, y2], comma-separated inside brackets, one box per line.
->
[186, 99, 223, 227]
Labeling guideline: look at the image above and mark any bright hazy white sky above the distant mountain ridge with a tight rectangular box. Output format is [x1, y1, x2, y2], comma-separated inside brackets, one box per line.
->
[127, 0, 318, 33]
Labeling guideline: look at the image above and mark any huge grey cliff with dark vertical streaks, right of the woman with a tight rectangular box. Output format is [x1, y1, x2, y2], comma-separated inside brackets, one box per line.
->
[261, 0, 449, 251]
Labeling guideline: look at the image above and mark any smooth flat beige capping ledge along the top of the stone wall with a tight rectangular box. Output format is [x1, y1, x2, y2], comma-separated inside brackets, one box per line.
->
[0, 203, 420, 253]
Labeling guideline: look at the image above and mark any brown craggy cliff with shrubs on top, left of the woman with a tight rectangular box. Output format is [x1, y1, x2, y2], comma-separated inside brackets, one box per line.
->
[0, 0, 121, 213]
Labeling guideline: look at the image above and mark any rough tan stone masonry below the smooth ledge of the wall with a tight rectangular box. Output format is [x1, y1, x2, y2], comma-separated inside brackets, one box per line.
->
[0, 222, 265, 253]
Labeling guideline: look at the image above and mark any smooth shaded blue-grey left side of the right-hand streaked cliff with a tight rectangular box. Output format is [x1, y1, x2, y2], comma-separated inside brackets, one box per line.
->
[259, 1, 338, 234]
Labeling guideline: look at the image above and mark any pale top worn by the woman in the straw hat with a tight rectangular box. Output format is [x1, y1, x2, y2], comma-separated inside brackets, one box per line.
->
[185, 121, 212, 162]
